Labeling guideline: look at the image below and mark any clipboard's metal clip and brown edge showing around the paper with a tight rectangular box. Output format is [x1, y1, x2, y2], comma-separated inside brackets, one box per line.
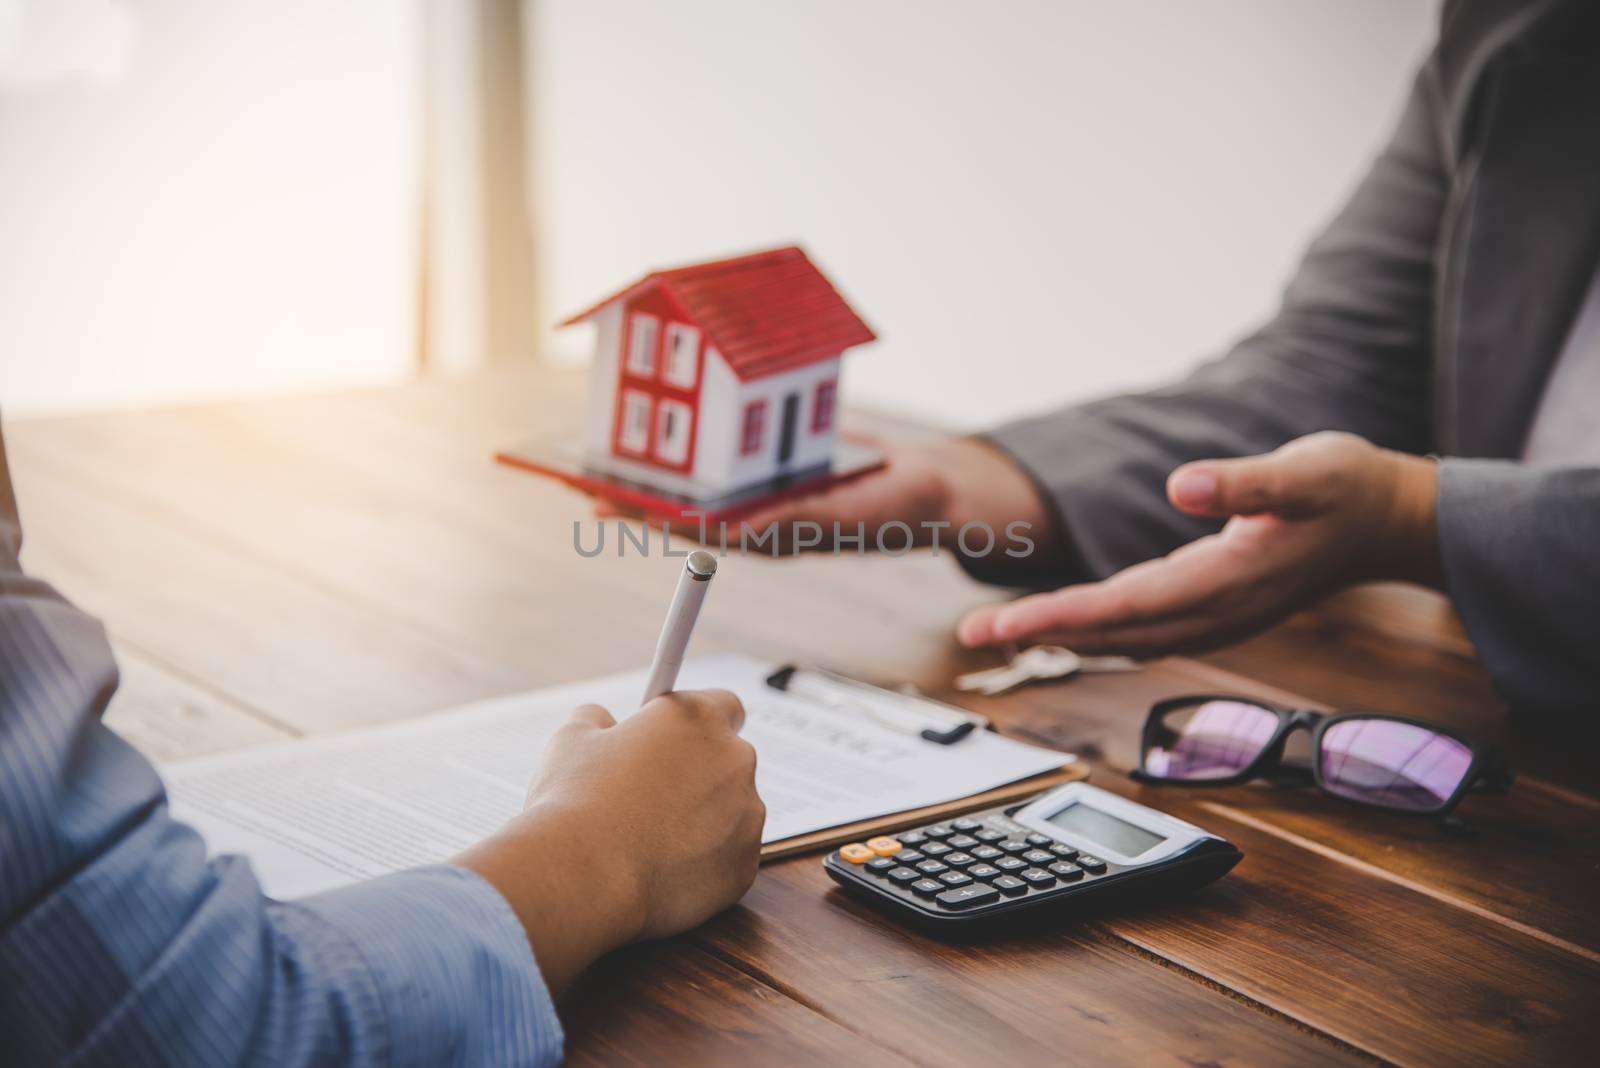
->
[762, 665, 1090, 863]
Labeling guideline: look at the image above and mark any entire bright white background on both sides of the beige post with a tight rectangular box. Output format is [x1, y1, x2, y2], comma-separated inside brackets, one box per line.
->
[0, 0, 1435, 425]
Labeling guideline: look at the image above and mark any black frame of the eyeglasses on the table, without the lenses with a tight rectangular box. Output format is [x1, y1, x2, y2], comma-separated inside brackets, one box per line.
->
[1130, 694, 1515, 819]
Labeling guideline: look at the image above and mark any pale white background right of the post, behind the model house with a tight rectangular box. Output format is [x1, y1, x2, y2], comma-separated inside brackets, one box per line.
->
[528, 0, 1435, 427]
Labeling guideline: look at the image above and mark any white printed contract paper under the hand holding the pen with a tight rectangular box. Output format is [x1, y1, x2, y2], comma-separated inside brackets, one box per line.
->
[162, 656, 1074, 899]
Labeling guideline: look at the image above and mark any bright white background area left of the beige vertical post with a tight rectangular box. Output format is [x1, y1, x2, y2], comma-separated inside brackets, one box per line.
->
[0, 0, 422, 416]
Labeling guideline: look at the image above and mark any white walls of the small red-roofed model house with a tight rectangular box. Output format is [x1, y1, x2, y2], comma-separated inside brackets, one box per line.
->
[581, 301, 838, 497]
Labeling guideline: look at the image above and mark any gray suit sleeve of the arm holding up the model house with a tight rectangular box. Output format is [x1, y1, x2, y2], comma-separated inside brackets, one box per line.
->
[963, 61, 1448, 585]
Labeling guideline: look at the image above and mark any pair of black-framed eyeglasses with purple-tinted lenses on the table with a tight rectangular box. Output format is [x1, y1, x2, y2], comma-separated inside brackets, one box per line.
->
[1133, 694, 1512, 817]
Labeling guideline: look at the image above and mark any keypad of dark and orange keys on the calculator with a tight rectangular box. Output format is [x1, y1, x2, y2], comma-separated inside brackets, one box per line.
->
[838, 808, 1107, 911]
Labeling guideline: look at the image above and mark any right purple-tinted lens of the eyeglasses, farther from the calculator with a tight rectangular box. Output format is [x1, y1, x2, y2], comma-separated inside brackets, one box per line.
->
[1317, 719, 1472, 812]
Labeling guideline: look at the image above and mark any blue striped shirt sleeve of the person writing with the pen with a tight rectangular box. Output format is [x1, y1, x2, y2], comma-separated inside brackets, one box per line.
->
[0, 428, 562, 1066]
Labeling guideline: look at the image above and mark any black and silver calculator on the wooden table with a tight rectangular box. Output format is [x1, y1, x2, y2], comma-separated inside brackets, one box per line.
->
[822, 782, 1243, 927]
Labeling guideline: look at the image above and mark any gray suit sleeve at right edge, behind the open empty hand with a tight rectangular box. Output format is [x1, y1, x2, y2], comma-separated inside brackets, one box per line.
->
[1438, 459, 1600, 711]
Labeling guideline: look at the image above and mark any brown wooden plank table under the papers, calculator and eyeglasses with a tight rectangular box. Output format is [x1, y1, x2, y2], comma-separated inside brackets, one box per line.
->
[6, 369, 1600, 1066]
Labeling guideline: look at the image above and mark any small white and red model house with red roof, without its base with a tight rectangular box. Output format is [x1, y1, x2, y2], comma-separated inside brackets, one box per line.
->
[566, 248, 874, 500]
